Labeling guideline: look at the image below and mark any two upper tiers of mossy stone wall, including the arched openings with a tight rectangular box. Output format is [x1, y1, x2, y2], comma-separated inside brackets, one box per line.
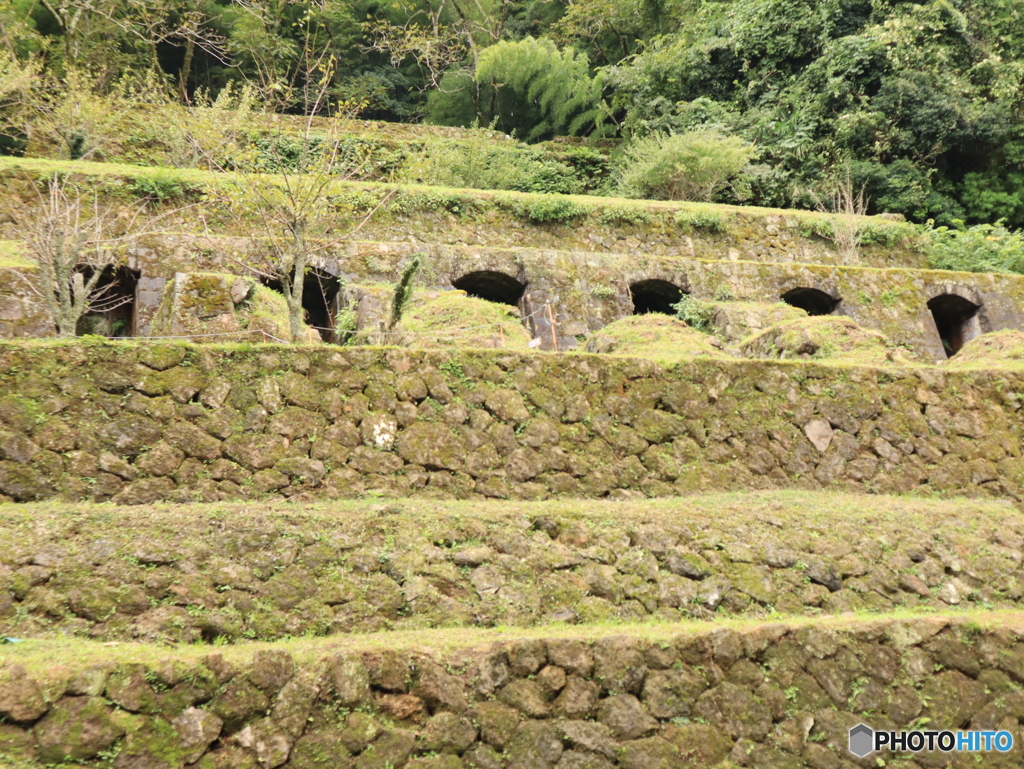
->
[0, 162, 1024, 364]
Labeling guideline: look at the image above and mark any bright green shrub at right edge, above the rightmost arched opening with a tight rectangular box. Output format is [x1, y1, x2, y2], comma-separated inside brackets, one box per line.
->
[928, 220, 1024, 273]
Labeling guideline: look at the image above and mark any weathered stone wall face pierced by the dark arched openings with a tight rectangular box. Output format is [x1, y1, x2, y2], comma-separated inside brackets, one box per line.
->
[121, 234, 1024, 360]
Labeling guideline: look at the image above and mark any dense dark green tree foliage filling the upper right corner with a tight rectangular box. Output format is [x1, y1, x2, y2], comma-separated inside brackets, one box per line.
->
[608, 0, 1024, 226]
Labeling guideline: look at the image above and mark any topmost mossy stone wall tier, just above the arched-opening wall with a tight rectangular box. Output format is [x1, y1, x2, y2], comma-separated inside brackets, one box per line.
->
[0, 158, 926, 269]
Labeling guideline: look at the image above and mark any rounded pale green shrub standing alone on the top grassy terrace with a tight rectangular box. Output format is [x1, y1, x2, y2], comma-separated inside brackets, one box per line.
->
[618, 131, 755, 201]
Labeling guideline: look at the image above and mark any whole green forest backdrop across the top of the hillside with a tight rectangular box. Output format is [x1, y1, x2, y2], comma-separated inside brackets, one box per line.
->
[6, 0, 1024, 229]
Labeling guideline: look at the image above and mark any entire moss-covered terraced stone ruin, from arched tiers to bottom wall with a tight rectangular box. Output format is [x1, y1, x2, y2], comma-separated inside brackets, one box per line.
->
[0, 144, 1024, 769]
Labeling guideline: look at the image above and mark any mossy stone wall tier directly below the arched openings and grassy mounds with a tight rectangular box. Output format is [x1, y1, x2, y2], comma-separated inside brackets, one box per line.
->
[0, 343, 1024, 504]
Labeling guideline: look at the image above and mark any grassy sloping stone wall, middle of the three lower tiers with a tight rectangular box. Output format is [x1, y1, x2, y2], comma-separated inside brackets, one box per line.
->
[0, 493, 1024, 643]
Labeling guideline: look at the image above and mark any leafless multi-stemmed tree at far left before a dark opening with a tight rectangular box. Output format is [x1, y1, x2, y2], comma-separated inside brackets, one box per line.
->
[5, 178, 178, 337]
